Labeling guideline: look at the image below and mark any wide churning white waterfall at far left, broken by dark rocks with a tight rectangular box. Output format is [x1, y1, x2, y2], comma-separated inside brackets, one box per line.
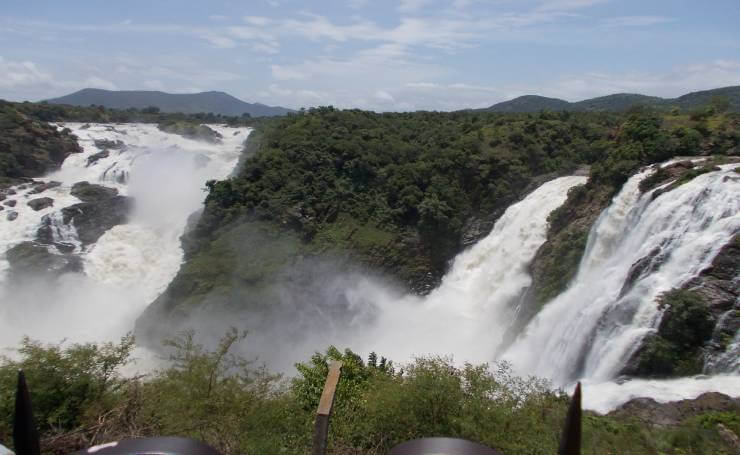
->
[0, 123, 250, 346]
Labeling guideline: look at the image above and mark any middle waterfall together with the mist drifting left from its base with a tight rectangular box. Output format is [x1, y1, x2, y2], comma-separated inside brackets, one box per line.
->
[140, 177, 586, 374]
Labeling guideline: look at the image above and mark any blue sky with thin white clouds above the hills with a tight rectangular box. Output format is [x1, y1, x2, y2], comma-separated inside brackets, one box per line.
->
[0, 0, 740, 111]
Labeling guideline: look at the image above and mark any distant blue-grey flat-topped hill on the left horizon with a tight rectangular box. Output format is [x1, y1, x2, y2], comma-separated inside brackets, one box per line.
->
[46, 88, 293, 117]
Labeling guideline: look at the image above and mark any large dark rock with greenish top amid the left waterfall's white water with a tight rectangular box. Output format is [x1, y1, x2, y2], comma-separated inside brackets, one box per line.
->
[62, 182, 133, 245]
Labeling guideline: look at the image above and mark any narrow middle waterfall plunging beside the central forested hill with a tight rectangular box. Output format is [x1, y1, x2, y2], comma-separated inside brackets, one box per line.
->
[342, 176, 587, 362]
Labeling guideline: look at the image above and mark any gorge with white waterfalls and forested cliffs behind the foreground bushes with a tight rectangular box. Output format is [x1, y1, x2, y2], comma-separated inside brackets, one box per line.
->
[0, 104, 740, 455]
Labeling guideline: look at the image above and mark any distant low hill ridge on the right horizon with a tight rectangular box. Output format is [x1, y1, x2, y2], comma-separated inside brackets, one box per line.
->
[484, 85, 740, 112]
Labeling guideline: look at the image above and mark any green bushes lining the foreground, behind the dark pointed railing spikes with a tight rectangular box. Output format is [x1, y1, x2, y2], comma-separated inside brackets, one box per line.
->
[0, 331, 740, 455]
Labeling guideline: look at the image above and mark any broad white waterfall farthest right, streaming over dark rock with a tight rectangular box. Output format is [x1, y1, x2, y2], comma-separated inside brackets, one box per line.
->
[504, 165, 740, 385]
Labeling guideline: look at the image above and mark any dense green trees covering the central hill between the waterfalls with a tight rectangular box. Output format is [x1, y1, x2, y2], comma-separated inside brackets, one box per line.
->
[195, 107, 619, 290]
